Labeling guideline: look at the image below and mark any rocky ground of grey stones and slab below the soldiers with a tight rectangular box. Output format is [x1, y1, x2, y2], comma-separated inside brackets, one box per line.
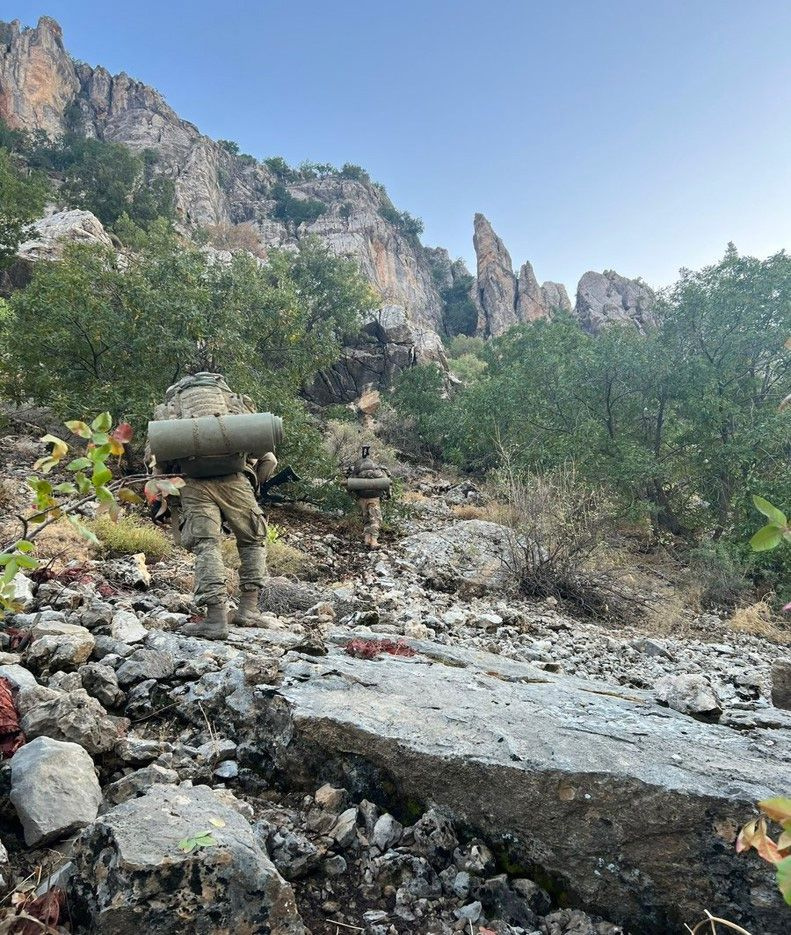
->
[0, 438, 791, 935]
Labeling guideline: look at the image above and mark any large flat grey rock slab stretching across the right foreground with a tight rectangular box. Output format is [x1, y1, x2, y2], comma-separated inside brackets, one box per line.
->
[270, 635, 791, 935]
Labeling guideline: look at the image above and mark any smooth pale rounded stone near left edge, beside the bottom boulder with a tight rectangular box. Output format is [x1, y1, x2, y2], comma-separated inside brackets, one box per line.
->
[10, 737, 102, 847]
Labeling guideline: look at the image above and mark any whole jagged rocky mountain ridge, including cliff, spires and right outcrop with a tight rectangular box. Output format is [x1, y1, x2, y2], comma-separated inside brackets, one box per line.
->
[0, 17, 652, 401]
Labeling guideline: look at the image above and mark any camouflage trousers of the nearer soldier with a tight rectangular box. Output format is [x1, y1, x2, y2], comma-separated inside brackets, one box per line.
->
[179, 474, 266, 604]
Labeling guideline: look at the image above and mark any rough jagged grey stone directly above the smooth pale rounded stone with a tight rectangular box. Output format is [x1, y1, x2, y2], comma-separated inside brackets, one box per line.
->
[17, 686, 119, 756]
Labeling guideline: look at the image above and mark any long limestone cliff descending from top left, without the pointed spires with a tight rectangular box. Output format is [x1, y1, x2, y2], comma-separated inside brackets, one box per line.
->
[0, 17, 444, 401]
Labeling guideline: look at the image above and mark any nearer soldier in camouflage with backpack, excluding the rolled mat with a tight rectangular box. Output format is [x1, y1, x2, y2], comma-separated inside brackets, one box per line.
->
[147, 372, 277, 639]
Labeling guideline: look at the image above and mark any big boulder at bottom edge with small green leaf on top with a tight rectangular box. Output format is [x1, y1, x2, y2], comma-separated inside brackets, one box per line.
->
[68, 785, 306, 935]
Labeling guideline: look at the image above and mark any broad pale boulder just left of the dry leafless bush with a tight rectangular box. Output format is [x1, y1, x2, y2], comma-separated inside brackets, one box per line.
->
[401, 519, 512, 590]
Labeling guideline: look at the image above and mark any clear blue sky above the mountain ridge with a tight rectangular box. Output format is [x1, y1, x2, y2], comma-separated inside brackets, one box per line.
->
[7, 0, 791, 290]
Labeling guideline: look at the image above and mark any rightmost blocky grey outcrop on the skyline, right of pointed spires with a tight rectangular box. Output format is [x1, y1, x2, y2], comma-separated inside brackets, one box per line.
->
[575, 270, 655, 334]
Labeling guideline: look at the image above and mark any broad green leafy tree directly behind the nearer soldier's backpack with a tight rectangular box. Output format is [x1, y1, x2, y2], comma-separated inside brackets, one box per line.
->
[0, 227, 375, 482]
